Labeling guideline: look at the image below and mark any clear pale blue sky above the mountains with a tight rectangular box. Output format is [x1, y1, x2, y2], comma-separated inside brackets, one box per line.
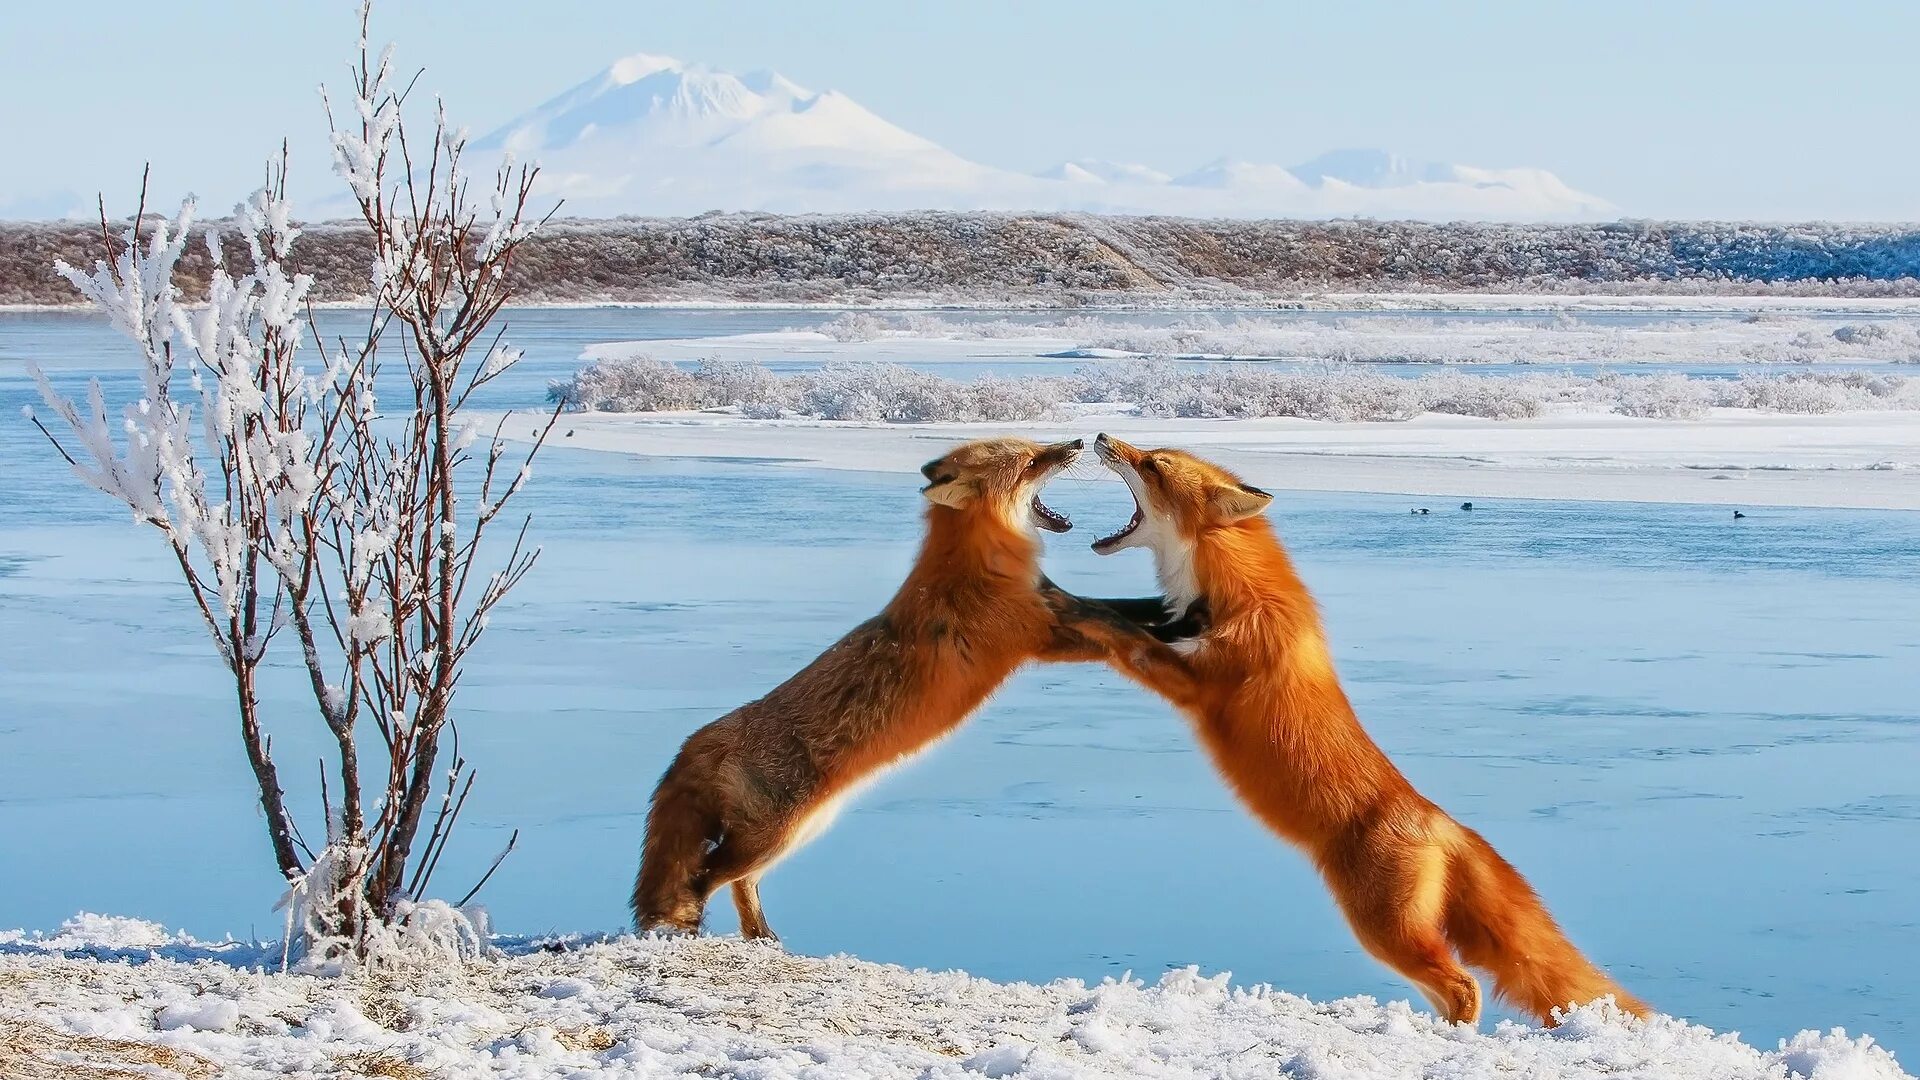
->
[0, 0, 1920, 219]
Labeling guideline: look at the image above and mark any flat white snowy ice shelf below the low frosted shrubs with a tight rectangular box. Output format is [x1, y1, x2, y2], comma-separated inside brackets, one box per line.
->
[484, 409, 1920, 509]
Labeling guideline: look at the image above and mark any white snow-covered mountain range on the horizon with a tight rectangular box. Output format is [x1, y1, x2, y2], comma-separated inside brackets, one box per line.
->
[472, 54, 1615, 221]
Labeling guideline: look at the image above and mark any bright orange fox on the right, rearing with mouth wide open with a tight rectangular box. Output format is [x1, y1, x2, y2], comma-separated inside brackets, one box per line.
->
[1092, 434, 1647, 1024]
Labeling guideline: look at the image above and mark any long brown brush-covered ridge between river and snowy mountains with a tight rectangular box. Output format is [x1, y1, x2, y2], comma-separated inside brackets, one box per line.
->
[0, 211, 1920, 307]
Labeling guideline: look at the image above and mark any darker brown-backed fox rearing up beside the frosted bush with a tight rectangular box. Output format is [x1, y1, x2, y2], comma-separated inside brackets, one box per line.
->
[634, 438, 1190, 938]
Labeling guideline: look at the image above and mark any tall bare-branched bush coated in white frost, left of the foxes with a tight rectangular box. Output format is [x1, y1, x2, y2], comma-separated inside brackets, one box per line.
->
[27, 4, 559, 953]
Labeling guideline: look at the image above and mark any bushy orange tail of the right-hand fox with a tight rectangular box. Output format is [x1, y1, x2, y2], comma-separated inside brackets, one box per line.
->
[1446, 826, 1651, 1024]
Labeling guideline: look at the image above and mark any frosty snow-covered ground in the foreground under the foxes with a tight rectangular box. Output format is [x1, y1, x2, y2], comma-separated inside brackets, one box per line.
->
[0, 924, 1910, 1080]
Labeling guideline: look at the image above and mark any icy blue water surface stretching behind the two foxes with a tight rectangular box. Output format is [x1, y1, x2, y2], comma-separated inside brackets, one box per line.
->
[0, 311, 1920, 1067]
